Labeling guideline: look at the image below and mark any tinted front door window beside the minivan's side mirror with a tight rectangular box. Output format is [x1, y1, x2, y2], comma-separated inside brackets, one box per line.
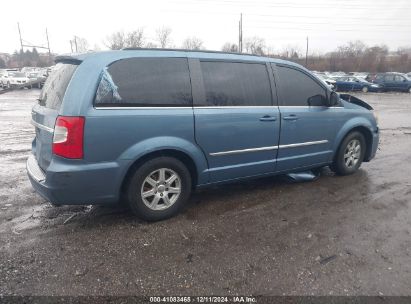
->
[278, 66, 327, 106]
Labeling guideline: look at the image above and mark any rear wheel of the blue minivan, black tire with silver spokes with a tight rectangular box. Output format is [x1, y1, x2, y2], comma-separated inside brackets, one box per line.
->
[125, 157, 191, 221]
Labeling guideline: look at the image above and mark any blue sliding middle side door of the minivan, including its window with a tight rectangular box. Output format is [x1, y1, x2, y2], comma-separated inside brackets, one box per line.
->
[190, 60, 280, 181]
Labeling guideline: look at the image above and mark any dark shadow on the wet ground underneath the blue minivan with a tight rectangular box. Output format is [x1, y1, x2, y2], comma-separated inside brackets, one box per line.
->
[34, 168, 354, 228]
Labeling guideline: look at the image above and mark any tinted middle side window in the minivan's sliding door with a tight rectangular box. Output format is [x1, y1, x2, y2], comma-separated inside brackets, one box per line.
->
[201, 61, 271, 106]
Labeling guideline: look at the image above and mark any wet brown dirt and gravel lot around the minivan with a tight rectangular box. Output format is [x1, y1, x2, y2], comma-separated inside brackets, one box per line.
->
[0, 89, 411, 295]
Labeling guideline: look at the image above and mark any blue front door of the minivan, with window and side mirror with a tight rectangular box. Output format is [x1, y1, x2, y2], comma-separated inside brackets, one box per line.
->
[273, 65, 344, 171]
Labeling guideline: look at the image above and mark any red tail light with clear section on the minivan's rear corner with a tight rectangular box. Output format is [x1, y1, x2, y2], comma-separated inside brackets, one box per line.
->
[53, 116, 85, 159]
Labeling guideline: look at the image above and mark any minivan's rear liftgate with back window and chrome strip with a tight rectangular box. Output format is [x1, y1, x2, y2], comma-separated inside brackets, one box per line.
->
[31, 63, 78, 170]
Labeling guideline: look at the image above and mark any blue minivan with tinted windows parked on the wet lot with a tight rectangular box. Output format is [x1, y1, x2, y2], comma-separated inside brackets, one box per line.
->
[27, 49, 379, 221]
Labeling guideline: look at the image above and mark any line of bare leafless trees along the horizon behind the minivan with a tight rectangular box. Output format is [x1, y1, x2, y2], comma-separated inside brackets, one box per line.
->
[0, 26, 411, 73]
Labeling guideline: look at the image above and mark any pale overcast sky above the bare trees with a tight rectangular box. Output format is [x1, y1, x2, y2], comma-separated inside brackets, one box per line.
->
[0, 0, 411, 53]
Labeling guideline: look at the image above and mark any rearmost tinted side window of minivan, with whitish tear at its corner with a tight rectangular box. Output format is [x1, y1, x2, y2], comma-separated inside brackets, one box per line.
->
[95, 58, 192, 106]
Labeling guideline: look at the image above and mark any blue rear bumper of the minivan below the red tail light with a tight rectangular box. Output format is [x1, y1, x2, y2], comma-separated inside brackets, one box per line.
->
[26, 156, 122, 205]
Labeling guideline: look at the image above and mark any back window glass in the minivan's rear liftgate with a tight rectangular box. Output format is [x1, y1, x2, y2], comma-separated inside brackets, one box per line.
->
[39, 63, 78, 110]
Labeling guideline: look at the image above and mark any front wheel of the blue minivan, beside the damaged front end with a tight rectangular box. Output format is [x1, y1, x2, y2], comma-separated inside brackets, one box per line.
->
[331, 131, 366, 175]
